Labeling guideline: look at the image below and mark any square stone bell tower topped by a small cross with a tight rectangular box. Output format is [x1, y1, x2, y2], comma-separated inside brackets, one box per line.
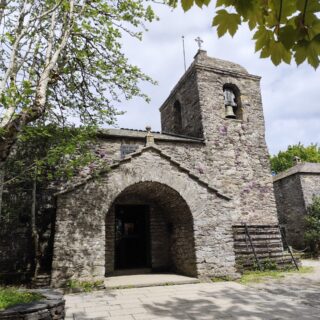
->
[160, 50, 277, 223]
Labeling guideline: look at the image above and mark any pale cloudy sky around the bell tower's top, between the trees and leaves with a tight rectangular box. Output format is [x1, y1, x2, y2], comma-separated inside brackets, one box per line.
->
[109, 4, 320, 154]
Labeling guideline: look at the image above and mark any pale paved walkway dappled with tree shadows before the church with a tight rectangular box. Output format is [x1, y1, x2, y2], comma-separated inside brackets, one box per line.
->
[65, 260, 320, 320]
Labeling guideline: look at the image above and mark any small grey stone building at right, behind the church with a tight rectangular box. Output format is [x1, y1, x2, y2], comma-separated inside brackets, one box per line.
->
[273, 162, 320, 250]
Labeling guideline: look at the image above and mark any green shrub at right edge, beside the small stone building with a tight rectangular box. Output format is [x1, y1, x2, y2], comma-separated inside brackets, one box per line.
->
[304, 197, 320, 256]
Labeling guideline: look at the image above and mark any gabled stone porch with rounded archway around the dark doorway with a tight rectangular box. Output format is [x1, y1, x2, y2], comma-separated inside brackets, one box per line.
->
[52, 148, 235, 285]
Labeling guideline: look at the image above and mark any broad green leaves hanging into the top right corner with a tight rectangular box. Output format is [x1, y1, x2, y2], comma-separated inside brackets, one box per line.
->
[168, 0, 320, 69]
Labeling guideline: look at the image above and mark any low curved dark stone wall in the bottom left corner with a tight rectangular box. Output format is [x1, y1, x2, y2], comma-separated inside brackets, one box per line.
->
[0, 289, 65, 320]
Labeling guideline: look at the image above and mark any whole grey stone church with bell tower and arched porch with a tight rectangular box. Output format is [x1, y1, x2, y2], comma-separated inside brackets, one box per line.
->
[51, 50, 288, 286]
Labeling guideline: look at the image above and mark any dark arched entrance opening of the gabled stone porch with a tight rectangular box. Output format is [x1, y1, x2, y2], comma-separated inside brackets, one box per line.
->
[106, 181, 197, 276]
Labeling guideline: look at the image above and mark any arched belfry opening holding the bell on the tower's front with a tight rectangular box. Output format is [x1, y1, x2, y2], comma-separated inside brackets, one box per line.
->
[223, 84, 242, 120]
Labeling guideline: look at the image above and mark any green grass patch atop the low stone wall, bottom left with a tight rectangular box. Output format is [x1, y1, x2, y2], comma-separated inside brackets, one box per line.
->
[0, 287, 43, 310]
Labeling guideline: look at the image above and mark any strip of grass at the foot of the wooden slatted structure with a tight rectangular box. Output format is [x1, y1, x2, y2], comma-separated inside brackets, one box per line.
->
[238, 267, 314, 284]
